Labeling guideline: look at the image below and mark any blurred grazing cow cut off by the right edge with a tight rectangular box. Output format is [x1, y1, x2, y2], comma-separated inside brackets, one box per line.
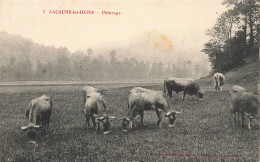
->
[230, 86, 259, 129]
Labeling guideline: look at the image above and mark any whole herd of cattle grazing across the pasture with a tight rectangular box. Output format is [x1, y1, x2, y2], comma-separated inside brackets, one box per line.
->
[21, 73, 259, 139]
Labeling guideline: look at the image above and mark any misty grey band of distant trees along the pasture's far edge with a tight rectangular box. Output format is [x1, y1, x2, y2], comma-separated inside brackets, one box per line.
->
[0, 33, 208, 81]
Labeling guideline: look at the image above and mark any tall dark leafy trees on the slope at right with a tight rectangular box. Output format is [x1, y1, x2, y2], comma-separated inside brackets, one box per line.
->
[202, 0, 260, 72]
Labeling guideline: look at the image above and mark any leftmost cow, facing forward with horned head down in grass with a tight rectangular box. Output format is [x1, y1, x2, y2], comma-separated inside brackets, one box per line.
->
[21, 95, 52, 138]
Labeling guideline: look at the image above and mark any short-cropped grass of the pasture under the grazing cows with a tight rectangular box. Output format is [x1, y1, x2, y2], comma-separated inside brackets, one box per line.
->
[0, 84, 259, 161]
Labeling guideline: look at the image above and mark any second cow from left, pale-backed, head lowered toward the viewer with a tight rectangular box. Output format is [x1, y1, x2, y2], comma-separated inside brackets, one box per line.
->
[83, 86, 116, 134]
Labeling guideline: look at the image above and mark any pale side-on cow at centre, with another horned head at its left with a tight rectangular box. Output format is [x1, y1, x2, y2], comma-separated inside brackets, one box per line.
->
[121, 87, 180, 131]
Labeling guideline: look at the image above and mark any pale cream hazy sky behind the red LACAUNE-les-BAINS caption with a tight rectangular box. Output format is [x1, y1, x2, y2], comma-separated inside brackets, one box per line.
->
[0, 0, 225, 58]
